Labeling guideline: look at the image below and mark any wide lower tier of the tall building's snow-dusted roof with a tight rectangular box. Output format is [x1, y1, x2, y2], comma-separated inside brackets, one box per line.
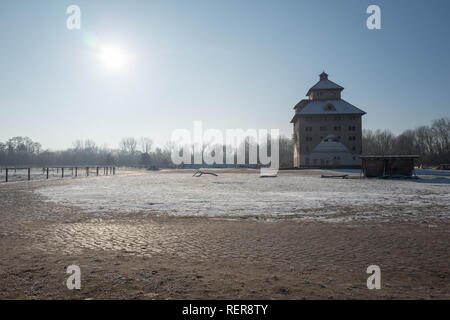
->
[296, 99, 366, 115]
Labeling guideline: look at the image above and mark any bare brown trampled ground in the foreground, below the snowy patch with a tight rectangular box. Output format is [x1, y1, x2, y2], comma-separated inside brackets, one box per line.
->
[0, 171, 450, 299]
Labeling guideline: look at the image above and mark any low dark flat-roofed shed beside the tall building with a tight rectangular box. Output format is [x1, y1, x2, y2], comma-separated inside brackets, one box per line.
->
[360, 155, 419, 178]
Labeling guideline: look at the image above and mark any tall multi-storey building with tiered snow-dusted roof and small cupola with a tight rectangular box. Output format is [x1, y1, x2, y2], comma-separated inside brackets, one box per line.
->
[291, 72, 366, 167]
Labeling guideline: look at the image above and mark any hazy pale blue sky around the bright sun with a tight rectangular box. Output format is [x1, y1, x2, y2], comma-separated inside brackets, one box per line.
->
[0, 0, 450, 149]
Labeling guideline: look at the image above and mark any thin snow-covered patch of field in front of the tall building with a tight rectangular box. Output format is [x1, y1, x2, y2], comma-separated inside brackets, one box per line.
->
[38, 170, 450, 222]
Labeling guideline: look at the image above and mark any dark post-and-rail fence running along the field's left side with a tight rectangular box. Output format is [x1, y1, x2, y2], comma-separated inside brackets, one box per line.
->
[0, 166, 116, 182]
